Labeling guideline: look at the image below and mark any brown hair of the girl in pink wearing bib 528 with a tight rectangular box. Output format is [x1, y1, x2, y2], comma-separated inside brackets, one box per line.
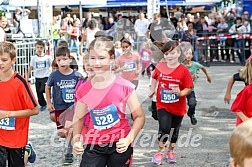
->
[88, 37, 115, 59]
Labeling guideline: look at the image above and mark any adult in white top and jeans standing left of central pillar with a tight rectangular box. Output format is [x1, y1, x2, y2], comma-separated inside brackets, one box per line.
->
[135, 13, 149, 52]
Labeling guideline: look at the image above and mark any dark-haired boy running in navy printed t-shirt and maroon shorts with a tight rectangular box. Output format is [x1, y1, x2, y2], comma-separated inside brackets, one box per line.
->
[46, 47, 80, 165]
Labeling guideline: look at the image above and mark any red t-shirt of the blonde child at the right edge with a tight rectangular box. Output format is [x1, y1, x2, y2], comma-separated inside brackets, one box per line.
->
[231, 84, 252, 126]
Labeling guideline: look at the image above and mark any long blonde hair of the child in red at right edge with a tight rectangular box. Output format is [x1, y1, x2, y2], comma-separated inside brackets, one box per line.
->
[239, 56, 252, 84]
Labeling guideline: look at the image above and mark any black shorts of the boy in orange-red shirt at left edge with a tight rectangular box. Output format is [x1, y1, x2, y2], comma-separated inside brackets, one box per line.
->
[0, 146, 25, 167]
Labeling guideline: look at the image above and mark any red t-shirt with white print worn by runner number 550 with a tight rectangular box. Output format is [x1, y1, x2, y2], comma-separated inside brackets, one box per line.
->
[152, 62, 193, 116]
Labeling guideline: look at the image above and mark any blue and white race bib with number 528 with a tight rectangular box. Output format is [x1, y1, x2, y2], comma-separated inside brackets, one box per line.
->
[90, 104, 120, 130]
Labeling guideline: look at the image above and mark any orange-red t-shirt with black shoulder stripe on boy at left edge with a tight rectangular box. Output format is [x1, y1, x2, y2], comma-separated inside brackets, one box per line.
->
[0, 72, 37, 148]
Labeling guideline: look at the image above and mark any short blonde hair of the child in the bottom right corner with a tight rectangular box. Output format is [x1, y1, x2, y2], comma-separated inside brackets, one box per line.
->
[229, 119, 252, 167]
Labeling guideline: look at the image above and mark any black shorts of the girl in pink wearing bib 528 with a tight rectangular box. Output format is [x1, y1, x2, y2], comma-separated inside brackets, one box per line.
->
[80, 143, 133, 167]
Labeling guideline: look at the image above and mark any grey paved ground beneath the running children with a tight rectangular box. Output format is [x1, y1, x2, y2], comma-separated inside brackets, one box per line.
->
[26, 66, 244, 167]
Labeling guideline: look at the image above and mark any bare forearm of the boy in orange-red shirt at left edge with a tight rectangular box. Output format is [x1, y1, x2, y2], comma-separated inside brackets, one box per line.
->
[0, 106, 39, 119]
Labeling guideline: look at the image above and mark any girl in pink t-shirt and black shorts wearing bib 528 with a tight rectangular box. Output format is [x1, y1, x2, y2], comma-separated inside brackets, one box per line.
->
[73, 37, 145, 167]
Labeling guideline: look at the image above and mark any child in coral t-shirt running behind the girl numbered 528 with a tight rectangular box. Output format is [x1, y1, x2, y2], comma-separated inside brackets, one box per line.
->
[115, 40, 140, 89]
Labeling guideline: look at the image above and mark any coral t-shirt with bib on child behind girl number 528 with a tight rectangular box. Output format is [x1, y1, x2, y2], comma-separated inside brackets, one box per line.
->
[116, 54, 139, 81]
